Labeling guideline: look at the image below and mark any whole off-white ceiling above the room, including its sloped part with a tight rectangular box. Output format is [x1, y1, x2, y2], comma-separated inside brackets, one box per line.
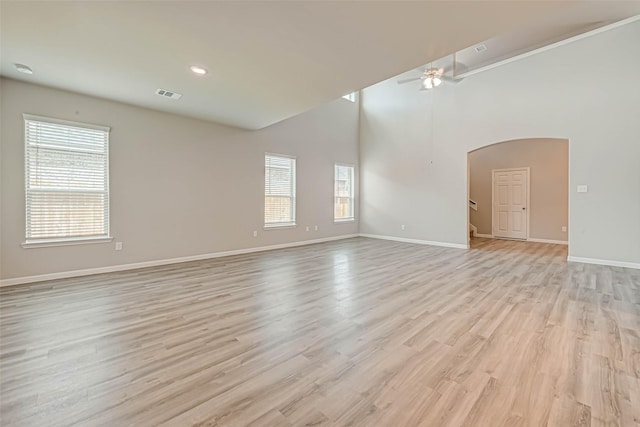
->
[0, 0, 640, 129]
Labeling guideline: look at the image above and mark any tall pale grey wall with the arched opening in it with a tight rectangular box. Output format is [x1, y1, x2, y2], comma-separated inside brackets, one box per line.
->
[360, 21, 640, 265]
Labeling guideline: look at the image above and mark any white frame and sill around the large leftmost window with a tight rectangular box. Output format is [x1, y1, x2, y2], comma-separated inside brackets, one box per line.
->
[21, 113, 113, 248]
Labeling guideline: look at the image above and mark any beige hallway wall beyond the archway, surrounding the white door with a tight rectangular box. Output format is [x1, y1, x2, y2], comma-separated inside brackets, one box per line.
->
[468, 138, 569, 242]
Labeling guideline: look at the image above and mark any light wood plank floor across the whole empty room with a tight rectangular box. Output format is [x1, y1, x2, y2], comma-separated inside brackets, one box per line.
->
[0, 238, 640, 427]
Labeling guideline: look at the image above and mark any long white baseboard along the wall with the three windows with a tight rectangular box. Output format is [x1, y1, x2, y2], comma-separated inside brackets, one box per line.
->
[0, 234, 358, 287]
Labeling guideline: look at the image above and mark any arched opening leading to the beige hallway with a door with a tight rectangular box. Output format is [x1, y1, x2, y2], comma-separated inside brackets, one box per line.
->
[467, 138, 570, 245]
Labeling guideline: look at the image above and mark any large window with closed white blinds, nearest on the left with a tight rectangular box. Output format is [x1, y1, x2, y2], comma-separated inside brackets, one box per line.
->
[24, 114, 109, 245]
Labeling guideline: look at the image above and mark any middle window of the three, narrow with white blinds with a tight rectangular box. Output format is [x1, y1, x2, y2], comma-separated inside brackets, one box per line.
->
[264, 154, 296, 227]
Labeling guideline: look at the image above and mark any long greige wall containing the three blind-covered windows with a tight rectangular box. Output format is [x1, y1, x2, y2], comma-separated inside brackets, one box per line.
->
[0, 79, 358, 279]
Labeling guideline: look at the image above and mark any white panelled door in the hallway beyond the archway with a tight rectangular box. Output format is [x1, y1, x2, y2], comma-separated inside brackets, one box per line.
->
[493, 168, 529, 240]
